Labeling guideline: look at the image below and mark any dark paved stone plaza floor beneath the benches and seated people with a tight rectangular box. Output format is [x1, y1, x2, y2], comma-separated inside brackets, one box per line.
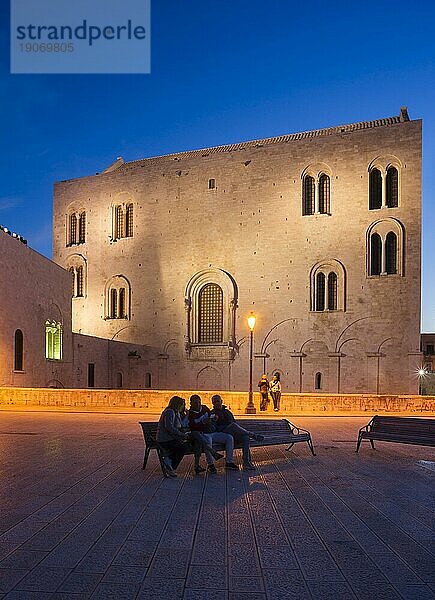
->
[0, 412, 435, 600]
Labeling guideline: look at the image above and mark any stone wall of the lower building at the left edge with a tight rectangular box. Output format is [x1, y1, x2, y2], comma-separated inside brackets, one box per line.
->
[0, 230, 73, 387]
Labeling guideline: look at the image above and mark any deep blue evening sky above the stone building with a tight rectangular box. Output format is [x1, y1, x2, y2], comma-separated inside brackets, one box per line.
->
[0, 0, 435, 331]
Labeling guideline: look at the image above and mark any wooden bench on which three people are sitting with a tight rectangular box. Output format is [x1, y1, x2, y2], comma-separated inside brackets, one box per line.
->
[139, 419, 316, 475]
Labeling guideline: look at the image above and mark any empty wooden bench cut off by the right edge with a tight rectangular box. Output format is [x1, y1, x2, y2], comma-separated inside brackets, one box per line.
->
[356, 415, 435, 452]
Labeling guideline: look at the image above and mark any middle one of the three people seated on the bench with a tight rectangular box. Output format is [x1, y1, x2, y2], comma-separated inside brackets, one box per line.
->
[189, 394, 239, 473]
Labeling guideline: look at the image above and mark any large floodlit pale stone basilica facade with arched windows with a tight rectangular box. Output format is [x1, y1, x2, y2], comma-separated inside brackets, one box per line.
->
[53, 108, 421, 393]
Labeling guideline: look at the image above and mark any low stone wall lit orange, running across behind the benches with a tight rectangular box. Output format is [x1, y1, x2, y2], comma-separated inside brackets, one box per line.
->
[0, 387, 435, 416]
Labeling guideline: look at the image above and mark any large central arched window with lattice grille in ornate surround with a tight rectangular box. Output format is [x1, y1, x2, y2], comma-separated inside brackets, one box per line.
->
[198, 283, 223, 344]
